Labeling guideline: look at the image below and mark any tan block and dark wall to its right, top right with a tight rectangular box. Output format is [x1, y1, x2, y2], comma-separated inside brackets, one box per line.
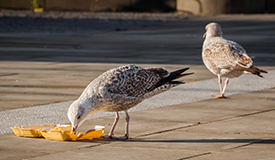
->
[177, 0, 275, 15]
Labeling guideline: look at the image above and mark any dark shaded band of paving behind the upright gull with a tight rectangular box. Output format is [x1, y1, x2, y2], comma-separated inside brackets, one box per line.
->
[0, 13, 275, 66]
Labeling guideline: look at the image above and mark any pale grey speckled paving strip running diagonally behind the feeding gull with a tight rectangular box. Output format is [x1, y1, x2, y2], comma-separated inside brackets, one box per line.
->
[0, 70, 275, 134]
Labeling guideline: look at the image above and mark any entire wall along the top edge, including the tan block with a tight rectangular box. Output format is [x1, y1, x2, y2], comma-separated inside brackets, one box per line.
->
[0, 0, 275, 15]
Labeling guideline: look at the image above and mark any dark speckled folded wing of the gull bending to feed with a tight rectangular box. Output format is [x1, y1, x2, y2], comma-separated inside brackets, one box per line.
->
[101, 65, 170, 98]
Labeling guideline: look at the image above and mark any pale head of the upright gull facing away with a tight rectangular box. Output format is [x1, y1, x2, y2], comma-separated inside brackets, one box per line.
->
[203, 22, 222, 38]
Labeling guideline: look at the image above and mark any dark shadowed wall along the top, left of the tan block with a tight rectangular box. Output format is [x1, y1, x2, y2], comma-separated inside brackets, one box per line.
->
[0, 0, 176, 12]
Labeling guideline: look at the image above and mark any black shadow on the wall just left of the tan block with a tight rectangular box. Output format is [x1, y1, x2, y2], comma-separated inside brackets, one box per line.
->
[121, 0, 176, 12]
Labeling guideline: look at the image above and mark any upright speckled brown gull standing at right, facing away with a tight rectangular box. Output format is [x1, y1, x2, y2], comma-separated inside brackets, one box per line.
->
[202, 23, 267, 98]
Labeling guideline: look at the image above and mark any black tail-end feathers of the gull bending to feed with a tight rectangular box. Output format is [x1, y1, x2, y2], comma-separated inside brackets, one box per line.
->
[150, 68, 194, 91]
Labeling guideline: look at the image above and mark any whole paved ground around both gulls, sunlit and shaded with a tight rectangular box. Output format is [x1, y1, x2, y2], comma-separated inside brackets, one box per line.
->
[0, 10, 275, 160]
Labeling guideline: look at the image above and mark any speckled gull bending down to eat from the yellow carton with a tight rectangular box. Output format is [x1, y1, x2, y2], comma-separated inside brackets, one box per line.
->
[68, 65, 193, 139]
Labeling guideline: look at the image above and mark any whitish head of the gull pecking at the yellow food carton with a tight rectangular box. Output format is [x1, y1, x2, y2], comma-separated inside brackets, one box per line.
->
[68, 100, 90, 133]
